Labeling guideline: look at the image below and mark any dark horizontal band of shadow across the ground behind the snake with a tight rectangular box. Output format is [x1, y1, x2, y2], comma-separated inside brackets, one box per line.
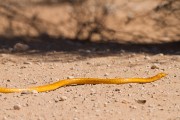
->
[0, 34, 180, 57]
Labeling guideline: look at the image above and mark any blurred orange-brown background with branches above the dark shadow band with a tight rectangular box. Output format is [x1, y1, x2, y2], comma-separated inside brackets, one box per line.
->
[0, 0, 180, 43]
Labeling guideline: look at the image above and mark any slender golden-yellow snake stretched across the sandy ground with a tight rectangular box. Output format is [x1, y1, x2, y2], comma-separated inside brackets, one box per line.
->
[0, 73, 167, 93]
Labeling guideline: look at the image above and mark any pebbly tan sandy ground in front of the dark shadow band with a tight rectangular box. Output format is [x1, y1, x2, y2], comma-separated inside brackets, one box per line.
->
[0, 47, 180, 120]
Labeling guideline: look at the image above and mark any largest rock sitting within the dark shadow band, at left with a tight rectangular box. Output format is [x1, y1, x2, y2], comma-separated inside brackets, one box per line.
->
[13, 43, 29, 52]
